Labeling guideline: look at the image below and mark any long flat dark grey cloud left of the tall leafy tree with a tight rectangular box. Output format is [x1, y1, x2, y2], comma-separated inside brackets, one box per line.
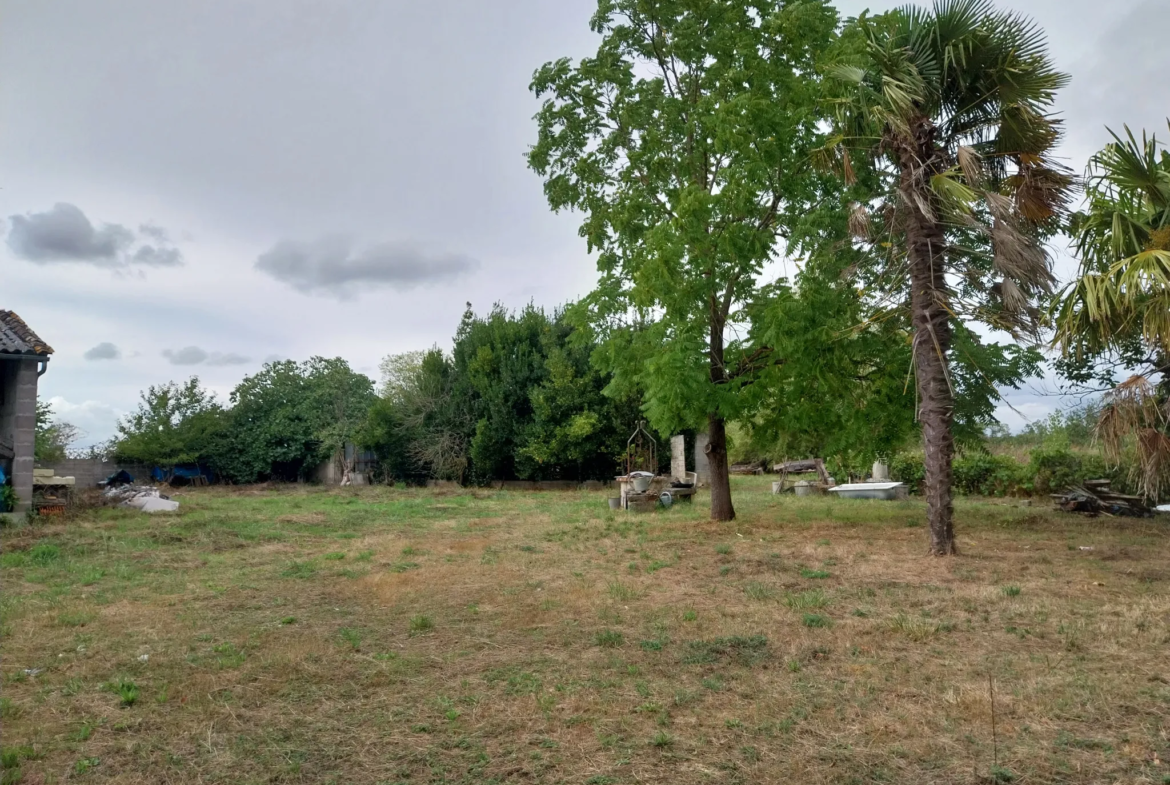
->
[255, 236, 480, 299]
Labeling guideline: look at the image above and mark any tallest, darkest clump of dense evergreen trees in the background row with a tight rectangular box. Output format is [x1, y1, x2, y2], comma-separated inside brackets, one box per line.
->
[360, 305, 638, 482]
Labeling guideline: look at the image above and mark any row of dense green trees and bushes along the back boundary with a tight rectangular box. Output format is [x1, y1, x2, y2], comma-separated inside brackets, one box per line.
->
[110, 307, 641, 483]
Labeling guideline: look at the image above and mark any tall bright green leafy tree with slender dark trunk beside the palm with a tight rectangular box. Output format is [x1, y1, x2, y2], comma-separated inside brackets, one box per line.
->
[528, 0, 837, 521]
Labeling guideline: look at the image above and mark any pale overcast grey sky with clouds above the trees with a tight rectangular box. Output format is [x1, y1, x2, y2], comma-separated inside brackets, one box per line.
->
[0, 0, 1170, 442]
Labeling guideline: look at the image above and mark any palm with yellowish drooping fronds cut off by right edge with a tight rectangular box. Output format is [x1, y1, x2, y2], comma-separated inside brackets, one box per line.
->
[1053, 122, 1170, 500]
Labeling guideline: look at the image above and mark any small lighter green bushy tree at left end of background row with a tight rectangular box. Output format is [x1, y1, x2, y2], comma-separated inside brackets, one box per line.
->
[113, 377, 228, 467]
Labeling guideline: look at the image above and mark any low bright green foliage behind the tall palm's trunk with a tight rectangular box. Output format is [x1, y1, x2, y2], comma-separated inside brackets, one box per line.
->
[734, 245, 1041, 474]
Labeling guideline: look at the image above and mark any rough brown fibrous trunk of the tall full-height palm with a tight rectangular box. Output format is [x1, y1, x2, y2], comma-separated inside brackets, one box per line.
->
[899, 119, 956, 556]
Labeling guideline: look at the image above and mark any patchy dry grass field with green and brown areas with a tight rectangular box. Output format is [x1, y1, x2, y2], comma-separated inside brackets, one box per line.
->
[0, 477, 1170, 785]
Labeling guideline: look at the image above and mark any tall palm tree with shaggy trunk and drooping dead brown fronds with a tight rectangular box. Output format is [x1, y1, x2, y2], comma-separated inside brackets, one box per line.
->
[830, 0, 1072, 556]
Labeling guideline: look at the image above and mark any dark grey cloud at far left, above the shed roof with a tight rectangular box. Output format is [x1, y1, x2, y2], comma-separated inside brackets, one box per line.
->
[8, 202, 183, 269]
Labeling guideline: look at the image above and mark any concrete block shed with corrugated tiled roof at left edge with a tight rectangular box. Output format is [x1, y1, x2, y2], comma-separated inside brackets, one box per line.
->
[0, 310, 53, 515]
